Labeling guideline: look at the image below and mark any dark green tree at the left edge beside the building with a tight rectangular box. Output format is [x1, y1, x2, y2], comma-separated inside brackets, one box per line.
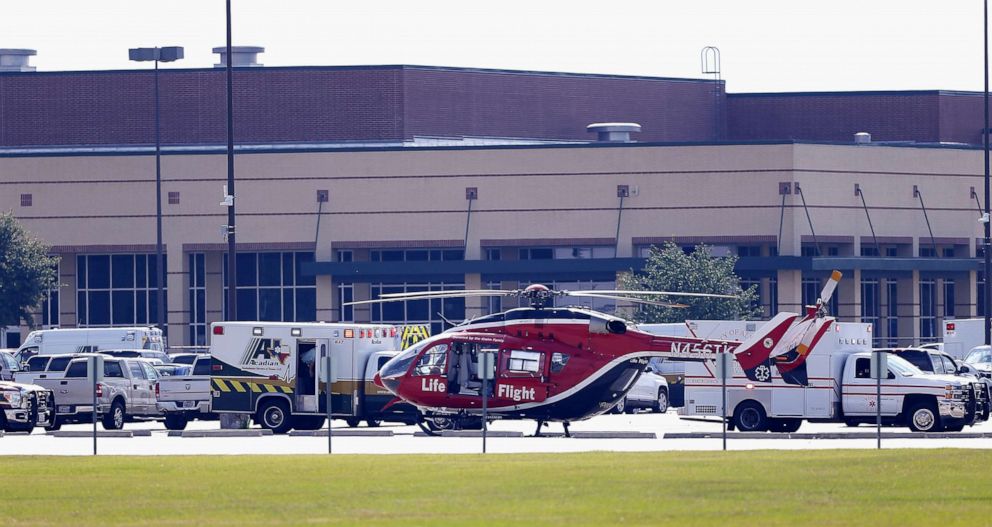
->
[0, 212, 59, 326]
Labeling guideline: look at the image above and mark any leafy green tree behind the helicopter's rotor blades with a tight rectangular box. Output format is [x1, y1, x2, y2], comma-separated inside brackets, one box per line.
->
[618, 242, 761, 323]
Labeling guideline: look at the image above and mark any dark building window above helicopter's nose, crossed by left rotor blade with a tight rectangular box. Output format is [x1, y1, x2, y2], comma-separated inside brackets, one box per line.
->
[370, 282, 465, 335]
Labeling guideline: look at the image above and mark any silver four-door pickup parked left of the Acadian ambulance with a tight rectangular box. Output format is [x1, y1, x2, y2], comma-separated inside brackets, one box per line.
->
[35, 357, 161, 430]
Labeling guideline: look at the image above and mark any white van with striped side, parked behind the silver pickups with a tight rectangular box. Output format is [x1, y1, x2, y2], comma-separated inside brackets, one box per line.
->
[14, 327, 165, 364]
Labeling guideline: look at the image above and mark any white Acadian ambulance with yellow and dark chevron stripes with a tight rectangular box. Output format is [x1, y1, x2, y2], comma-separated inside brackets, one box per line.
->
[210, 322, 427, 433]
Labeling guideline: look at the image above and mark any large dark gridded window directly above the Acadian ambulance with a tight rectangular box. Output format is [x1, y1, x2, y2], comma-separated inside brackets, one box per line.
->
[224, 252, 317, 322]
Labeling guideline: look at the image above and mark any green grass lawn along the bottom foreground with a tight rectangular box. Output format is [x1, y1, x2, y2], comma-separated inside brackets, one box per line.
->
[0, 450, 992, 526]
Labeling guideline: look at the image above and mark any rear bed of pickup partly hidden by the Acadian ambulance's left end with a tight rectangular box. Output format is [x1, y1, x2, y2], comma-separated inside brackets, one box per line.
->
[155, 355, 211, 430]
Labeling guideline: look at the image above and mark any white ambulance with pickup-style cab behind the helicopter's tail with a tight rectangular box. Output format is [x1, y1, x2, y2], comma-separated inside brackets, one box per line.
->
[679, 321, 987, 432]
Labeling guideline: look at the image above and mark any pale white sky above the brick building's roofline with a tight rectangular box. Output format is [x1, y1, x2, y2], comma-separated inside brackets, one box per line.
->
[0, 0, 983, 93]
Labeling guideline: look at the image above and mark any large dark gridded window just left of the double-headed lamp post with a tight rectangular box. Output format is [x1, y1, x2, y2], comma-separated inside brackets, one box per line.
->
[76, 254, 169, 327]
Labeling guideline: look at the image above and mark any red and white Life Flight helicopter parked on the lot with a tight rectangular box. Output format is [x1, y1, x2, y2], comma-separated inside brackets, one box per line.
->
[351, 271, 840, 435]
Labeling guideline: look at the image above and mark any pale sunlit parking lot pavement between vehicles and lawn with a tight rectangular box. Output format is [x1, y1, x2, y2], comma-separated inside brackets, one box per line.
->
[0, 411, 992, 455]
